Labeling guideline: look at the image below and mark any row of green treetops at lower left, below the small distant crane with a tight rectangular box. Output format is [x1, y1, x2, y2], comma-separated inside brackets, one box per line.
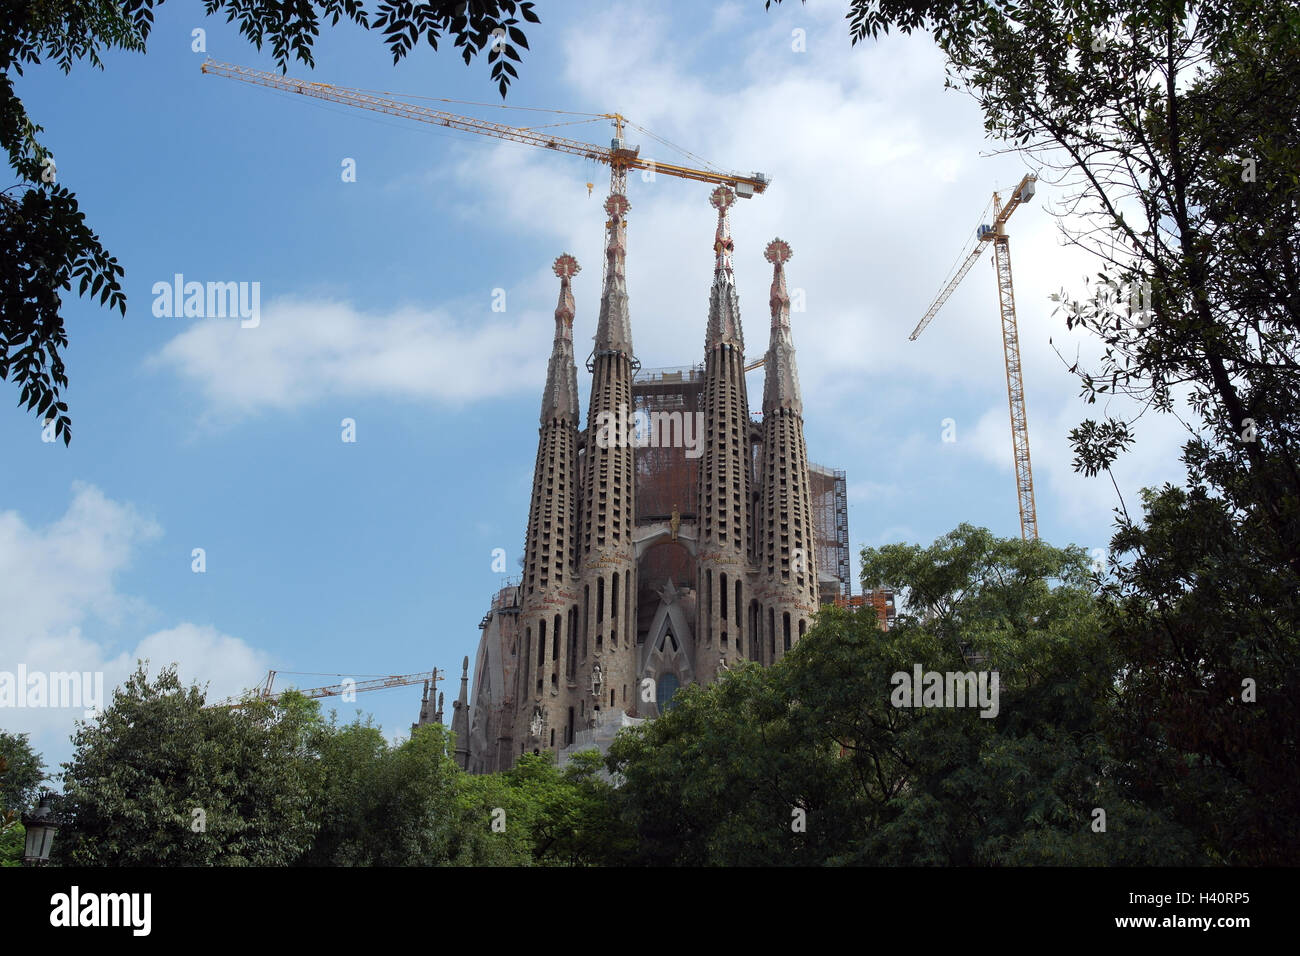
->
[53, 663, 618, 866]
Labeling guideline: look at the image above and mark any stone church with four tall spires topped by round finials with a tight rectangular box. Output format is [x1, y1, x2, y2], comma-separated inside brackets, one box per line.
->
[455, 187, 826, 773]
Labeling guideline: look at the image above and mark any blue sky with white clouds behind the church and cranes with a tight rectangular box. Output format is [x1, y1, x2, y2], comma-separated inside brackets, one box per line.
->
[0, 0, 1180, 780]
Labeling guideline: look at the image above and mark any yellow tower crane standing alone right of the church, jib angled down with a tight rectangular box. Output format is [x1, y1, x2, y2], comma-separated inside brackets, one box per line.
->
[907, 173, 1039, 541]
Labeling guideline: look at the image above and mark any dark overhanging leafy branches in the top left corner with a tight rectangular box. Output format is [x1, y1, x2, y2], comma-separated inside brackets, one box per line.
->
[0, 0, 540, 444]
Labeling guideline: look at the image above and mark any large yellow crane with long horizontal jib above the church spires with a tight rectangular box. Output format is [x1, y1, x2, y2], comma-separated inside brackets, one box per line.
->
[203, 60, 771, 199]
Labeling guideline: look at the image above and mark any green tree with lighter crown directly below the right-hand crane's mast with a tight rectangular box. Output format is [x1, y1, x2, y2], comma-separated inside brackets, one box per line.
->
[852, 524, 1203, 865]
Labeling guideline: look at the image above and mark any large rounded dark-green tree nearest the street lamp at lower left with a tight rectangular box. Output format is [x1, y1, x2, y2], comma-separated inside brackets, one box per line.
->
[53, 663, 320, 866]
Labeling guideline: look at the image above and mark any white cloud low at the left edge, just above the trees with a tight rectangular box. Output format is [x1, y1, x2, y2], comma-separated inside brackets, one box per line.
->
[0, 483, 269, 771]
